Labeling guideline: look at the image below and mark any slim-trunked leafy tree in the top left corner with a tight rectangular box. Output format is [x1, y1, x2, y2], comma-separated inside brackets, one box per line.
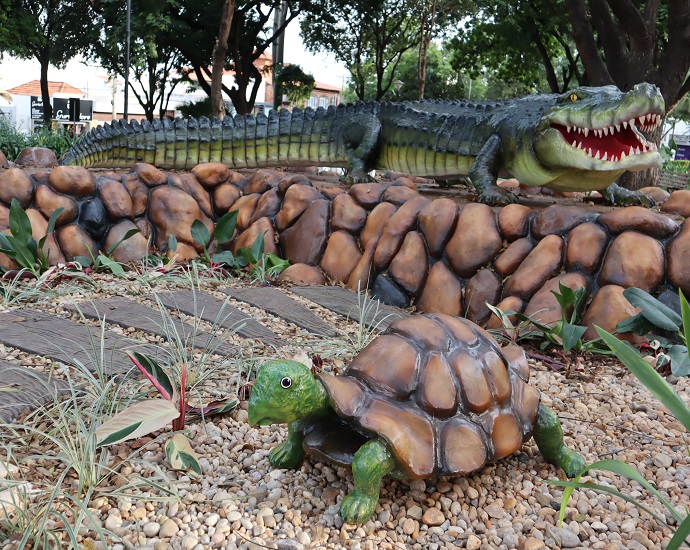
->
[0, 0, 98, 124]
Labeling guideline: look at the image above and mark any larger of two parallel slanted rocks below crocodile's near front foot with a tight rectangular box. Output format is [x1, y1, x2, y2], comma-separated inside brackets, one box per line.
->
[503, 235, 565, 299]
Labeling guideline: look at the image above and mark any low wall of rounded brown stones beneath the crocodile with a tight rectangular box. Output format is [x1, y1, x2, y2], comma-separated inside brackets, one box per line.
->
[0, 163, 690, 337]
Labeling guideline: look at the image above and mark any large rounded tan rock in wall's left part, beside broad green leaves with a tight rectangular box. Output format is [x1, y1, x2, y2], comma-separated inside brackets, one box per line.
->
[149, 189, 213, 250]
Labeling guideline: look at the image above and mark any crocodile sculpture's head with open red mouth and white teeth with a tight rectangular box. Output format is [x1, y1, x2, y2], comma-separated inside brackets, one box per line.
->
[534, 83, 664, 189]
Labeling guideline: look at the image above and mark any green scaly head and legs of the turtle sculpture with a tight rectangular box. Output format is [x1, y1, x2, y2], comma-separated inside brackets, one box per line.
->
[248, 361, 585, 523]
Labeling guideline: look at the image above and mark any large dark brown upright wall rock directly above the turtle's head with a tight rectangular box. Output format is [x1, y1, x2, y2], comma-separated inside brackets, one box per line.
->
[279, 201, 330, 265]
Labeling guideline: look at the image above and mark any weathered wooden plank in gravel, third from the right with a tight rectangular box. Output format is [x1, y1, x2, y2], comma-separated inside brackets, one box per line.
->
[146, 290, 285, 348]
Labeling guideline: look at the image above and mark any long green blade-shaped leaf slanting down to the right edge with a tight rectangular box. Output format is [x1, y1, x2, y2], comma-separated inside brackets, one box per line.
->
[595, 327, 690, 430]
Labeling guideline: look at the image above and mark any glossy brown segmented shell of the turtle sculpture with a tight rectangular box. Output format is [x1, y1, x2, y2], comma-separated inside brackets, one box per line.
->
[311, 314, 539, 478]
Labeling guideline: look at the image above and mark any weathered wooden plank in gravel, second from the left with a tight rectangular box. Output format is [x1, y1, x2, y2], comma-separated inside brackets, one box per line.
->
[0, 310, 161, 375]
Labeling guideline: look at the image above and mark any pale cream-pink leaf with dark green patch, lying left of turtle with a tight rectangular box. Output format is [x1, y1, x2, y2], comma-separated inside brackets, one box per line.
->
[96, 399, 180, 447]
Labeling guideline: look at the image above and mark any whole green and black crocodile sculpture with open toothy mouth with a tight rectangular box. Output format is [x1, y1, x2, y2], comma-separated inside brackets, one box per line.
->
[61, 83, 664, 204]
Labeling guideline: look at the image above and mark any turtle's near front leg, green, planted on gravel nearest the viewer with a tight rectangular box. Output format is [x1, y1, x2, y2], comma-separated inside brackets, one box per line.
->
[340, 439, 396, 523]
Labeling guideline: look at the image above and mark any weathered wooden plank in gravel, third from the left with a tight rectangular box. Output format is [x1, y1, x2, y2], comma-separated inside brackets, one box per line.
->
[65, 298, 237, 355]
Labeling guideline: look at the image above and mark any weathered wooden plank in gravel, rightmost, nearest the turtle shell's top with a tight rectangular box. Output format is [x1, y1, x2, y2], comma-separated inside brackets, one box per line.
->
[290, 286, 410, 331]
